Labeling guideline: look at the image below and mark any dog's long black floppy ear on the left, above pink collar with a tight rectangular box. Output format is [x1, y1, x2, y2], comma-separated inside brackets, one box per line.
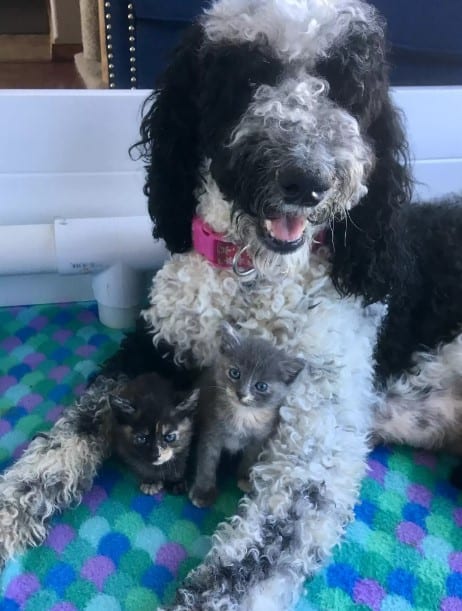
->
[135, 24, 203, 252]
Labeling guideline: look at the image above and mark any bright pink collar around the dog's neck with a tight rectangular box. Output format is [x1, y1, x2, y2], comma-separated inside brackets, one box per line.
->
[192, 216, 253, 271]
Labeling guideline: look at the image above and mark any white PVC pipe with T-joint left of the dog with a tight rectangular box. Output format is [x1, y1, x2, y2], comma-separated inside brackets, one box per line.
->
[0, 216, 167, 329]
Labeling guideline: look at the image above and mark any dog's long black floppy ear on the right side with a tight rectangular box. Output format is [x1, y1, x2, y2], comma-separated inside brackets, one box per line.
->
[318, 15, 412, 302]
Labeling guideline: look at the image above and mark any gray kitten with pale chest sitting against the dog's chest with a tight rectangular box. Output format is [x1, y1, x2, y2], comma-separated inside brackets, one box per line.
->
[189, 323, 305, 507]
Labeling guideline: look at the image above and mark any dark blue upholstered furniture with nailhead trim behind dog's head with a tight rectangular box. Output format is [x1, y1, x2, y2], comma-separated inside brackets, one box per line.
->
[103, 0, 462, 89]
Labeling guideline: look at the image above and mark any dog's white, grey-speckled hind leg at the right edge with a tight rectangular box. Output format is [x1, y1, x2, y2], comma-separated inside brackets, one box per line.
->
[373, 335, 462, 453]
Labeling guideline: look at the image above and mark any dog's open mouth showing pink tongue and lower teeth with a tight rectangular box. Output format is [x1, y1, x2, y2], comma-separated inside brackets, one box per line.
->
[260, 214, 307, 253]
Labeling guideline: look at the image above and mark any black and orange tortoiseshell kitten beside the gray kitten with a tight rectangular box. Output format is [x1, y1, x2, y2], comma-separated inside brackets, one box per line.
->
[110, 373, 199, 495]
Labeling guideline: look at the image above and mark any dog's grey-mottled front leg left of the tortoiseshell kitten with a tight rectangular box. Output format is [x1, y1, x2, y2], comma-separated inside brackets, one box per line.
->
[0, 377, 117, 566]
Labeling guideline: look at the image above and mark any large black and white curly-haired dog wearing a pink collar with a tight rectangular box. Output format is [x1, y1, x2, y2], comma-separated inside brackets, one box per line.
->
[0, 0, 462, 611]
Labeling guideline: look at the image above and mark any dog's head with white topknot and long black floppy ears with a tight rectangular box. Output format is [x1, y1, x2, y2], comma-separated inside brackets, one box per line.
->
[136, 0, 409, 293]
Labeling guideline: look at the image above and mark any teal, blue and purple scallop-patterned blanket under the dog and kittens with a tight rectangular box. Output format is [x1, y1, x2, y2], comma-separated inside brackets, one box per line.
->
[0, 303, 462, 611]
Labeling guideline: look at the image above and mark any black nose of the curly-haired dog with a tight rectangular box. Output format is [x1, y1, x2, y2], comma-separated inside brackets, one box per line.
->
[277, 166, 329, 206]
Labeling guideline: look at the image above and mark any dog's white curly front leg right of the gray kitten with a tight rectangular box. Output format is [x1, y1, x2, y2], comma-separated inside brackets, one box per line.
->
[162, 397, 367, 611]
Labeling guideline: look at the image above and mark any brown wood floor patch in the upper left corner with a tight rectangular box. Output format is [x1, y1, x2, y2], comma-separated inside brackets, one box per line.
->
[0, 61, 84, 89]
